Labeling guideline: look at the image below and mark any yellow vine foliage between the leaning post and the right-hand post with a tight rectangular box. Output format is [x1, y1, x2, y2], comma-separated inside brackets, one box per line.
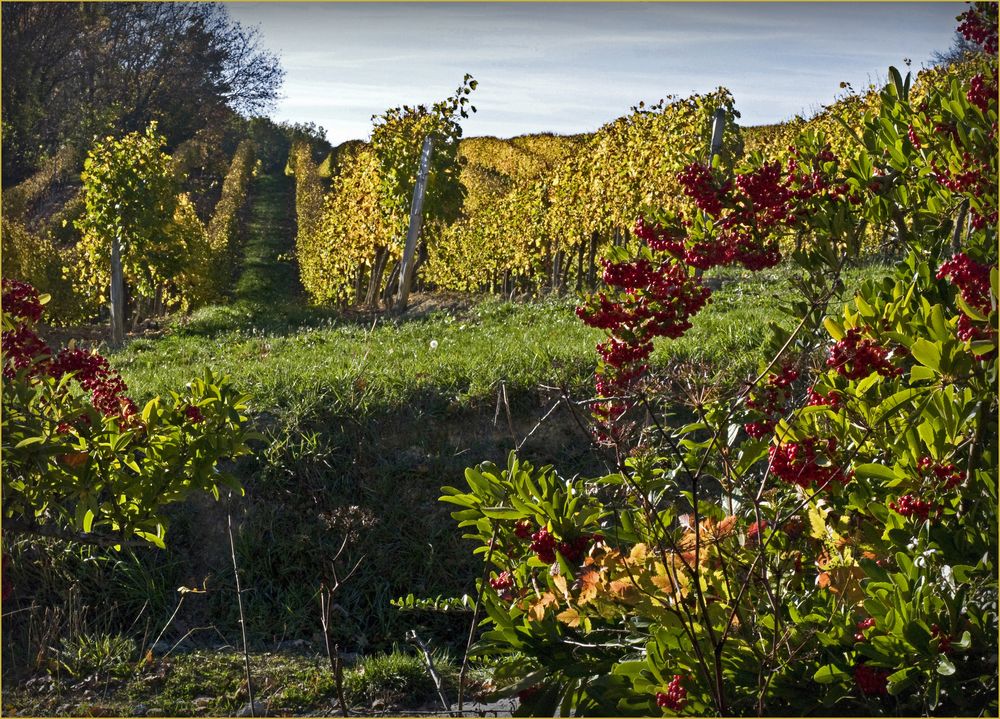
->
[424, 88, 742, 291]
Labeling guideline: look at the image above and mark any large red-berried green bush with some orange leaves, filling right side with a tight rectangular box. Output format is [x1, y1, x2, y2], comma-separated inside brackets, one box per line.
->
[443, 4, 998, 716]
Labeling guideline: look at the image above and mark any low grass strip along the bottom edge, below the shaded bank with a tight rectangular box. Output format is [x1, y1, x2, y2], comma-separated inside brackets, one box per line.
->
[4, 640, 472, 716]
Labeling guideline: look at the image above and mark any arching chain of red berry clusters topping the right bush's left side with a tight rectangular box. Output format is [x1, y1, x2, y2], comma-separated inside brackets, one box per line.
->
[577, 147, 853, 441]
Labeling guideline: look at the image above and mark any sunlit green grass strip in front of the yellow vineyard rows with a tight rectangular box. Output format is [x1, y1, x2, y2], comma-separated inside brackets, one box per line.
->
[113, 262, 888, 422]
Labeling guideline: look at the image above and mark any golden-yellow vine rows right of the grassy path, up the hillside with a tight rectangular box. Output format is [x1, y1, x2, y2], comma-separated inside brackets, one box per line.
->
[289, 61, 977, 304]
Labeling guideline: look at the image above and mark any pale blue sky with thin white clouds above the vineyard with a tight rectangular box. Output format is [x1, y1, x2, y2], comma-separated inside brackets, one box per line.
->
[226, 2, 965, 144]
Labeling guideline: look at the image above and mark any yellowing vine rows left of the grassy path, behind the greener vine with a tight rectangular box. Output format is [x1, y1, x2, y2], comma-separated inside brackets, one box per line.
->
[3, 133, 255, 324]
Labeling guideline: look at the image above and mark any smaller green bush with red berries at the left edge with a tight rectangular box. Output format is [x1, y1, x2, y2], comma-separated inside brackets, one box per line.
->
[2, 279, 249, 547]
